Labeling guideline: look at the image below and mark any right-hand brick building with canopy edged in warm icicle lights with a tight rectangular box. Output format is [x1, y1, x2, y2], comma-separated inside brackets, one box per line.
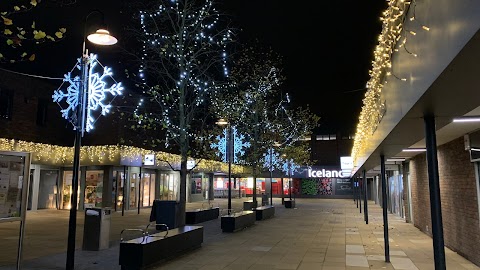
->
[352, 0, 480, 269]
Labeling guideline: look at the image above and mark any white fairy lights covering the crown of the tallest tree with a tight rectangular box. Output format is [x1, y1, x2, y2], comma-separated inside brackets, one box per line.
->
[134, 0, 232, 148]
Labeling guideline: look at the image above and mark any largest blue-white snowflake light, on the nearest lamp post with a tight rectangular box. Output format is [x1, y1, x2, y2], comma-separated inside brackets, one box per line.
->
[52, 54, 123, 132]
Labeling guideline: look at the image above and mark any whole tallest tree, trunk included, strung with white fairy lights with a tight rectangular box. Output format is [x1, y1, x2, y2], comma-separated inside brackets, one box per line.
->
[122, 0, 232, 226]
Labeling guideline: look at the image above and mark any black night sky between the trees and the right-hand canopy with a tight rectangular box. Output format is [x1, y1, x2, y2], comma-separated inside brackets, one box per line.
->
[221, 0, 386, 134]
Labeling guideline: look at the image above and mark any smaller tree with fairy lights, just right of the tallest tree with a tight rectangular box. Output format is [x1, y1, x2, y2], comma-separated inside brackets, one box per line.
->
[211, 42, 319, 200]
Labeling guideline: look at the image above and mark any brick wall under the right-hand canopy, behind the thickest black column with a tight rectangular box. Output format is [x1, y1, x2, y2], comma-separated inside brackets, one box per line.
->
[410, 137, 480, 265]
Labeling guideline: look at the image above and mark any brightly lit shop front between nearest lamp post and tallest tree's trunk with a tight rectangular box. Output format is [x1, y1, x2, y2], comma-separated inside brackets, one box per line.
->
[59, 166, 179, 211]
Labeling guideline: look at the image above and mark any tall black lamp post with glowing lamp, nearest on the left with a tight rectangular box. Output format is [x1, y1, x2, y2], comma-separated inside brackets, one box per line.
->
[66, 10, 117, 270]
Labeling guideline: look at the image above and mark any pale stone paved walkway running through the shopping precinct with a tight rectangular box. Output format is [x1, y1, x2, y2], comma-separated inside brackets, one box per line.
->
[0, 199, 480, 270]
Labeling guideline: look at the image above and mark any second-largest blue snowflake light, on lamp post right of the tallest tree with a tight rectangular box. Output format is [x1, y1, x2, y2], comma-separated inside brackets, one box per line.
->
[210, 127, 250, 164]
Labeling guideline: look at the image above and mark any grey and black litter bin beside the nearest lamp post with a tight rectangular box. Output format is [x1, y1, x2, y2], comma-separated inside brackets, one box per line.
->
[82, 208, 112, 251]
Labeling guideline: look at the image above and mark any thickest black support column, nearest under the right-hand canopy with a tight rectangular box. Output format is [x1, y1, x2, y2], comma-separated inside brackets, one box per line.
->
[423, 114, 446, 270]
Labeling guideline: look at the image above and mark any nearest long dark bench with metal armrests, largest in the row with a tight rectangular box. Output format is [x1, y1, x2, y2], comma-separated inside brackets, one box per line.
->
[119, 224, 203, 270]
